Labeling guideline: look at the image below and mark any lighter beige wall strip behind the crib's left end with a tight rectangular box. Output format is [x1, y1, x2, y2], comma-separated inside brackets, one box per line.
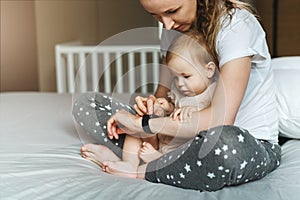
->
[35, 0, 98, 91]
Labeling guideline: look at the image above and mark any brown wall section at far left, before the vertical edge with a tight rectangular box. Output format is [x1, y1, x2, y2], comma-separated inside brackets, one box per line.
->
[0, 0, 38, 92]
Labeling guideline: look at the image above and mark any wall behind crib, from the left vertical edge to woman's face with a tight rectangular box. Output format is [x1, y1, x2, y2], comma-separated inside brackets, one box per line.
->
[35, 0, 156, 91]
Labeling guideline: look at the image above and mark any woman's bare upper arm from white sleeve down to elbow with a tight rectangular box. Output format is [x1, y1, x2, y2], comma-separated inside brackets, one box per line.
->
[210, 56, 252, 127]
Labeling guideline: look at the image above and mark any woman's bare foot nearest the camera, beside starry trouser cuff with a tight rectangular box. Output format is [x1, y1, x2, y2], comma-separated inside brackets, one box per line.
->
[102, 161, 137, 178]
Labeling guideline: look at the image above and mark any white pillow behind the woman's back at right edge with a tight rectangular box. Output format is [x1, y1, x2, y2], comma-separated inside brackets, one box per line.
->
[272, 56, 300, 139]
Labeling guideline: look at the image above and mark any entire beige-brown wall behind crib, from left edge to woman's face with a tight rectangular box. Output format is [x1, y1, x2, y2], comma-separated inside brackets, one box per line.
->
[1, 0, 156, 92]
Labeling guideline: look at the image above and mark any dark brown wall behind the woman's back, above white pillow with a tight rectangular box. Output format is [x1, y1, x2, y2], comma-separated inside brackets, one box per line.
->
[256, 0, 300, 56]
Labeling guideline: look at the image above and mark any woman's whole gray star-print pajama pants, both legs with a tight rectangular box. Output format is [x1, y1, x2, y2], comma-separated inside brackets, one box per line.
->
[73, 93, 281, 191]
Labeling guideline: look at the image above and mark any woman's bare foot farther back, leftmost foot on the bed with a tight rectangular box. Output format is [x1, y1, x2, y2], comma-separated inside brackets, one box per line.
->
[80, 144, 120, 167]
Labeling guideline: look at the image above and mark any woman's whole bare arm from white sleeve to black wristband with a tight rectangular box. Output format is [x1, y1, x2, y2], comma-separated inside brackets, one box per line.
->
[149, 57, 251, 138]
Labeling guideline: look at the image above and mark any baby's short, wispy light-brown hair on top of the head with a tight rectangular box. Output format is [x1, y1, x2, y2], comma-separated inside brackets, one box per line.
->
[166, 30, 218, 68]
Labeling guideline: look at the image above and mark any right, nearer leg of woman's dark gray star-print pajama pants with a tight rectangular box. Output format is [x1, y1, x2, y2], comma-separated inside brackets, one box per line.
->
[146, 126, 281, 191]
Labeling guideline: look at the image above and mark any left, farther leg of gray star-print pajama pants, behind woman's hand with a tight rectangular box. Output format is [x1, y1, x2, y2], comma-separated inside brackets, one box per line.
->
[73, 92, 135, 157]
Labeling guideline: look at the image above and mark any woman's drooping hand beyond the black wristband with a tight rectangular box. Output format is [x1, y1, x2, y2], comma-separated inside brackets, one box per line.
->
[107, 110, 143, 139]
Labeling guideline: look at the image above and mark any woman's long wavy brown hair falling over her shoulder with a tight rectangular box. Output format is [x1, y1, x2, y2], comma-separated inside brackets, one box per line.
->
[194, 0, 257, 64]
